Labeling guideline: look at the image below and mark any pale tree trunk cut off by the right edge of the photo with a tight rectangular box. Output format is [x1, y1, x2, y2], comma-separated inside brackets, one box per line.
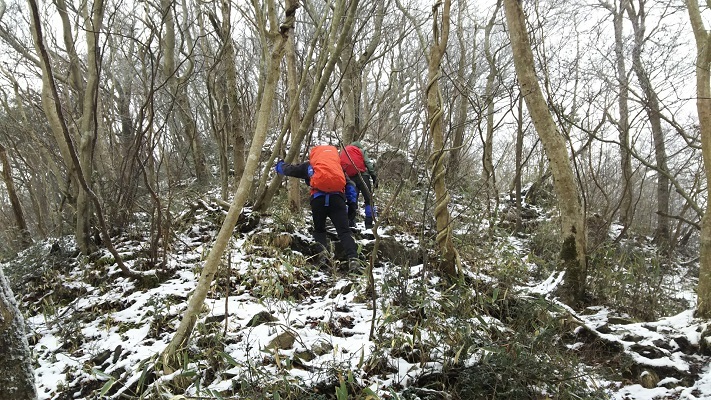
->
[686, 0, 711, 319]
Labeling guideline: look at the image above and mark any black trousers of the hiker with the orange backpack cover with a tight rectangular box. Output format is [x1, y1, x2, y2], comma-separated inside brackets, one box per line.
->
[311, 194, 358, 259]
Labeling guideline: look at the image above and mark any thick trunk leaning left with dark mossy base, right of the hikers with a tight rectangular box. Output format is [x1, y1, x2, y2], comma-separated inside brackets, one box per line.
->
[504, 0, 587, 305]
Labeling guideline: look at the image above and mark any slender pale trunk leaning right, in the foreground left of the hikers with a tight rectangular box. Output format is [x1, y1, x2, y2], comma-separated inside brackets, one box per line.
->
[161, 0, 298, 373]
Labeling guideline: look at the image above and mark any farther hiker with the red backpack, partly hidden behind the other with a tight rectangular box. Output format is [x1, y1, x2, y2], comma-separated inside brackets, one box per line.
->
[340, 141, 378, 229]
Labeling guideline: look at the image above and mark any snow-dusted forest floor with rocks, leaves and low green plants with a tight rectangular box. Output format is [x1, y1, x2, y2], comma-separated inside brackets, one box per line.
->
[0, 191, 711, 400]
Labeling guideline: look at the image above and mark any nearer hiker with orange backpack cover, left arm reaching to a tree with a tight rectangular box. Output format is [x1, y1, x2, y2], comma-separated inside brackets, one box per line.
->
[275, 146, 358, 269]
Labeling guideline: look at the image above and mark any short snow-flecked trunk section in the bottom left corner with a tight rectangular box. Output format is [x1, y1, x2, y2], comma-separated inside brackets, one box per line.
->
[0, 268, 37, 400]
